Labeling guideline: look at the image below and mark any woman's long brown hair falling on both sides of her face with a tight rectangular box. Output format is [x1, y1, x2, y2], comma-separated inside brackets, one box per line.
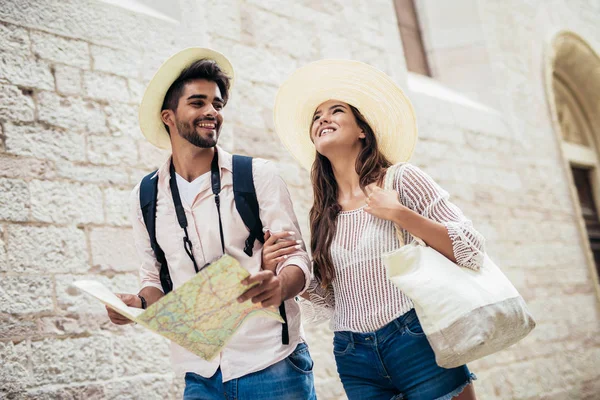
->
[309, 105, 391, 287]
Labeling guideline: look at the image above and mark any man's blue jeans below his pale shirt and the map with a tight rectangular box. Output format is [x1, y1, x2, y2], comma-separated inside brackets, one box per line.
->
[183, 343, 317, 400]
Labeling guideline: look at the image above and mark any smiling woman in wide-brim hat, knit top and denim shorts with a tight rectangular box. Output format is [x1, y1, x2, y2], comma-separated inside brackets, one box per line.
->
[272, 60, 484, 400]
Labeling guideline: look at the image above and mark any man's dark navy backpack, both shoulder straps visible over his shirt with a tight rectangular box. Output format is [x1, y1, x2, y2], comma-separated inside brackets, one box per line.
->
[140, 155, 289, 344]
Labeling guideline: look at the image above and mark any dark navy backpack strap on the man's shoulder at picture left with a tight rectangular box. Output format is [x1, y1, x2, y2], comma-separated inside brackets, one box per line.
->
[140, 171, 173, 294]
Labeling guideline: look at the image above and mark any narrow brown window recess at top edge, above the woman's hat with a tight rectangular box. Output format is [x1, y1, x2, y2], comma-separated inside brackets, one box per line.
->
[394, 0, 431, 76]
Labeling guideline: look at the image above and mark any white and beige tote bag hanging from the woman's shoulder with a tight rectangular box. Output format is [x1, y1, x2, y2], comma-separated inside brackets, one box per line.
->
[383, 168, 535, 368]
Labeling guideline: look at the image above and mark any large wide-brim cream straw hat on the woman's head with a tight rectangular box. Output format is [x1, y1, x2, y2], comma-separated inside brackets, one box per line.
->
[273, 60, 417, 171]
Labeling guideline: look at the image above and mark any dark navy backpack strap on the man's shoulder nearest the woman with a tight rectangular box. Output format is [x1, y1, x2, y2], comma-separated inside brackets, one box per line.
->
[233, 155, 290, 344]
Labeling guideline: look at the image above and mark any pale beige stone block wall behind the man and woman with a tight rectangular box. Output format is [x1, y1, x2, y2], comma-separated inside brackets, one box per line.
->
[0, 0, 600, 400]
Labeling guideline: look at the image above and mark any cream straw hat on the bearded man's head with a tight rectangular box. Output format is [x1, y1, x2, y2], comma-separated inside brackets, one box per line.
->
[138, 47, 234, 149]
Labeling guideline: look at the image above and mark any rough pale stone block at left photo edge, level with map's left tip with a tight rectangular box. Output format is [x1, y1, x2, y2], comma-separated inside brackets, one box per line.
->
[0, 276, 54, 314]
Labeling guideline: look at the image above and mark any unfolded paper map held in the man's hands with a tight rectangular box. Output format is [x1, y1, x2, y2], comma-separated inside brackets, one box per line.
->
[73, 255, 283, 360]
